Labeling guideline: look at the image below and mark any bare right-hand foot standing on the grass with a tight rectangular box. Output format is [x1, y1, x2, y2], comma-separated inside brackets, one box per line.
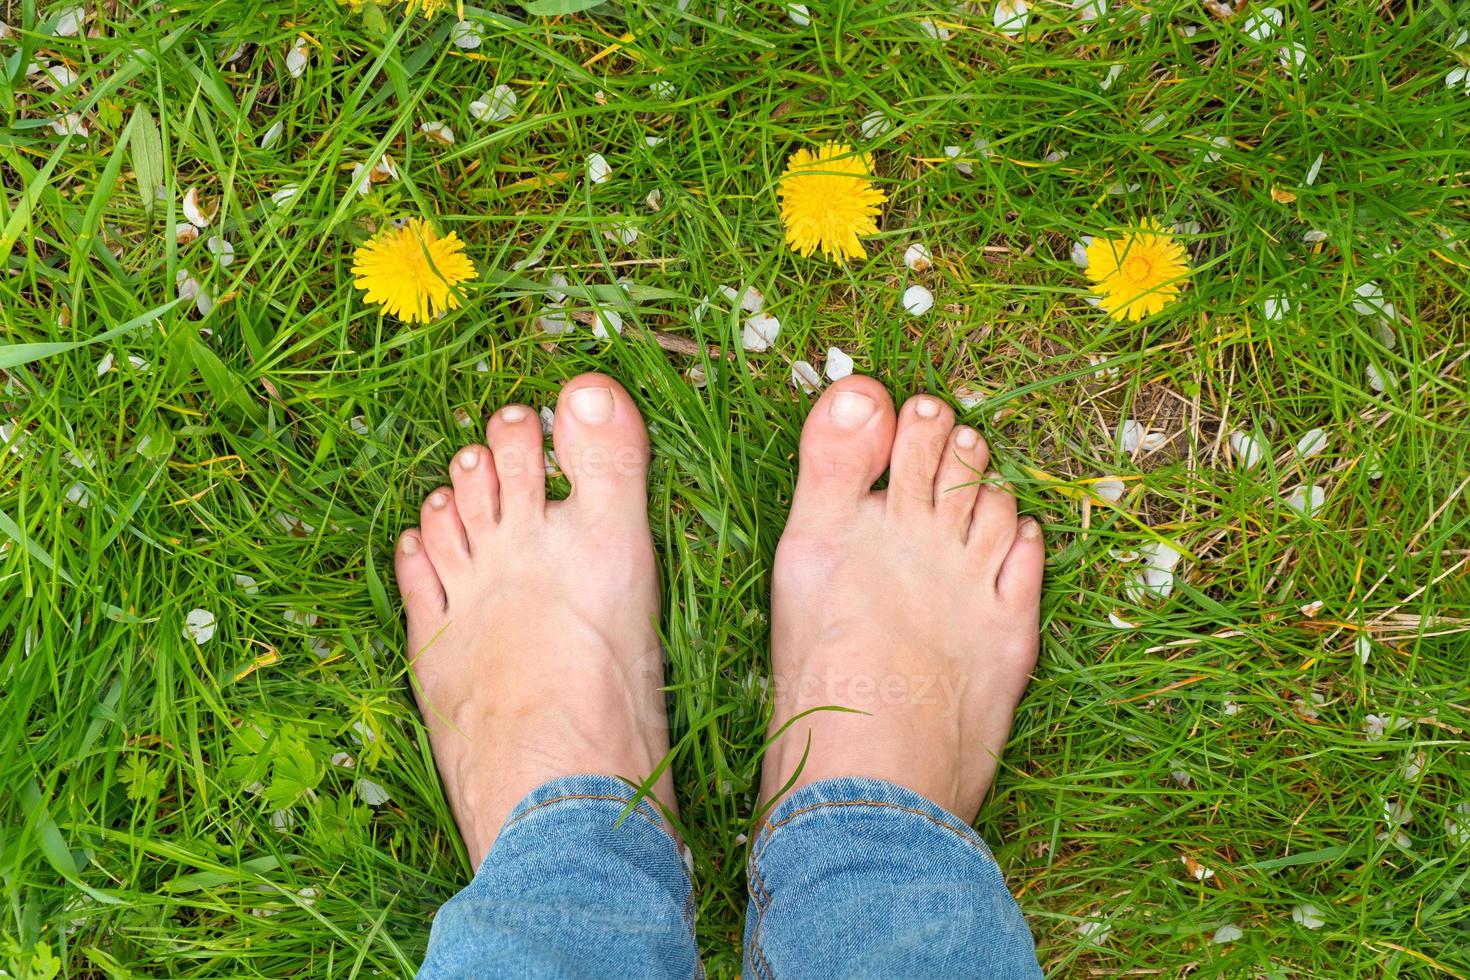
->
[761, 376, 1044, 821]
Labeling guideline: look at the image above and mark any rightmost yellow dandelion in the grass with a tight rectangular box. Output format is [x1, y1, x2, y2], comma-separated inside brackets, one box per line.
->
[1088, 220, 1189, 320]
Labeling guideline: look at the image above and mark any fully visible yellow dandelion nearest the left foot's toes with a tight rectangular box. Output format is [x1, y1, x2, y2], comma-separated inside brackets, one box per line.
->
[353, 217, 479, 323]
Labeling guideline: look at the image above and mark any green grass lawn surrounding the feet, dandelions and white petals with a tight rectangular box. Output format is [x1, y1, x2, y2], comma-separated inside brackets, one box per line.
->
[0, 0, 1470, 977]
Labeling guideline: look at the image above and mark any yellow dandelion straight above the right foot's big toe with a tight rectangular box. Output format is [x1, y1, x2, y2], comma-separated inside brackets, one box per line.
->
[779, 143, 888, 262]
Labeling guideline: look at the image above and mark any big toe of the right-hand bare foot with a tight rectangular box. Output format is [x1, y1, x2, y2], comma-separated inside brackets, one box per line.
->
[797, 375, 894, 504]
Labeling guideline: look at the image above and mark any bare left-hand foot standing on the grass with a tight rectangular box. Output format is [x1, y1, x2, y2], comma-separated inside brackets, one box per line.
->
[397, 375, 675, 865]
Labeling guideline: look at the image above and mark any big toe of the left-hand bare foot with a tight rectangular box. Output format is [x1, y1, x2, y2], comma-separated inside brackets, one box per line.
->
[551, 375, 648, 513]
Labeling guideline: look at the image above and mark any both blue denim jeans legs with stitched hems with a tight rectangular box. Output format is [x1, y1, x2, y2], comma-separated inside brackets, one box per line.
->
[419, 776, 1041, 980]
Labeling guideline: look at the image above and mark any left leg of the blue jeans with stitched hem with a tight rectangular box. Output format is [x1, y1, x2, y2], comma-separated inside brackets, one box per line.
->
[419, 776, 700, 980]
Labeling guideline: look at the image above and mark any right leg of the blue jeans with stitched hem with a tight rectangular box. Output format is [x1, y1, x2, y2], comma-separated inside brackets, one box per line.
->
[745, 777, 1041, 980]
